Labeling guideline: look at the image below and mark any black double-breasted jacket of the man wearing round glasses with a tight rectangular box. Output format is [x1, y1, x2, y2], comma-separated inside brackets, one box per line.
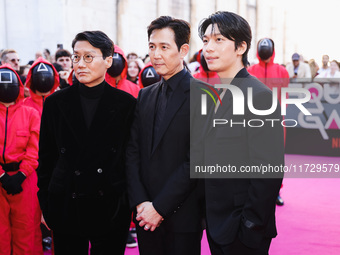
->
[38, 83, 136, 235]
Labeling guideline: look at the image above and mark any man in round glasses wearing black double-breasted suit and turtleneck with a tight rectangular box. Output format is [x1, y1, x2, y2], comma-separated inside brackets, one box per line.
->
[38, 31, 136, 255]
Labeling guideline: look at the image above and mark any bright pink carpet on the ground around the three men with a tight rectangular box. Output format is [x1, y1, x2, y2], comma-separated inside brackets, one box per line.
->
[45, 155, 340, 255]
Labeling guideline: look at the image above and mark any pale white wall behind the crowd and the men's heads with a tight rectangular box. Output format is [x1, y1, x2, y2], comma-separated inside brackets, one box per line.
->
[0, 0, 282, 64]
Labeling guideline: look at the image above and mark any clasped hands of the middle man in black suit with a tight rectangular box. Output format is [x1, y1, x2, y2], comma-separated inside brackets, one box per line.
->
[136, 201, 164, 231]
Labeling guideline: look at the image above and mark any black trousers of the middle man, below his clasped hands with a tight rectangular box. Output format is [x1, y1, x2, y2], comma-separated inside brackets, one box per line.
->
[136, 223, 202, 255]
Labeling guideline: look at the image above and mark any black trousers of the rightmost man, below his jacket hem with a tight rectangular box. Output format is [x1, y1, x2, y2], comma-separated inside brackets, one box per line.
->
[207, 233, 272, 255]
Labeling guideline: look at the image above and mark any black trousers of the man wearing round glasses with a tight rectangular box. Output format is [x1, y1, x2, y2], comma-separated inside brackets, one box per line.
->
[53, 227, 128, 255]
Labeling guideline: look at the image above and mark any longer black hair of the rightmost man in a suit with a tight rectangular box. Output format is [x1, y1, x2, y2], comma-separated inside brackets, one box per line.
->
[198, 11, 251, 66]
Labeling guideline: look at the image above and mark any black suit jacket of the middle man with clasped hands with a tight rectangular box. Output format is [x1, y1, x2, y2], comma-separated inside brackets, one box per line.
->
[127, 70, 202, 232]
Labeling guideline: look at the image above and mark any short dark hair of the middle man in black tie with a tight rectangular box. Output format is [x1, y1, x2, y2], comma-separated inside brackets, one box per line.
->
[148, 16, 190, 51]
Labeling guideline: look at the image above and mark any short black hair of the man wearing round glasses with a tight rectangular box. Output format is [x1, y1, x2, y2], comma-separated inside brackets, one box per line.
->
[72, 31, 114, 59]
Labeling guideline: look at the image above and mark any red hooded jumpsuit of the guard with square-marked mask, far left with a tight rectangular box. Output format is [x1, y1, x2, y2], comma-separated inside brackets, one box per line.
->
[0, 65, 42, 255]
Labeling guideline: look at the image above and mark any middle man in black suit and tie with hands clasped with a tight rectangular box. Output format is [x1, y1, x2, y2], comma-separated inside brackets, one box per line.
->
[127, 16, 202, 255]
